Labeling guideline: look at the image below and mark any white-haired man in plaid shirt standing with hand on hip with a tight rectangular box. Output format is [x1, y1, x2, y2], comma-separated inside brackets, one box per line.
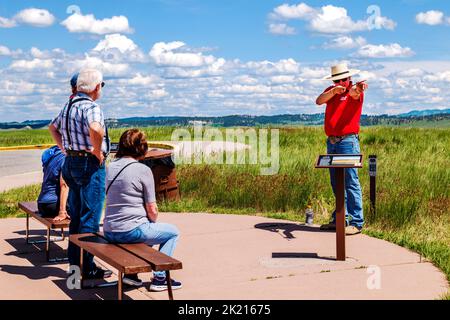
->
[49, 69, 111, 279]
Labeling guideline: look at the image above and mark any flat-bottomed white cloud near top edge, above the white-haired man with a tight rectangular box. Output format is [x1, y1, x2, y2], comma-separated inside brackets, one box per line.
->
[61, 13, 133, 34]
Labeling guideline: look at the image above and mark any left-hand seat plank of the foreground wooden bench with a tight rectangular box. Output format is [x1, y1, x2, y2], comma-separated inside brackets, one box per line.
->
[70, 233, 152, 274]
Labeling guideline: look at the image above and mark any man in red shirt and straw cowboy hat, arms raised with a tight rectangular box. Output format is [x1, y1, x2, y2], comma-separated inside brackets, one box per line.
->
[316, 64, 368, 235]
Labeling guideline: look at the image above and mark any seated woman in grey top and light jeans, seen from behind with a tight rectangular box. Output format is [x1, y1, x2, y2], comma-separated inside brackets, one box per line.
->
[103, 129, 181, 291]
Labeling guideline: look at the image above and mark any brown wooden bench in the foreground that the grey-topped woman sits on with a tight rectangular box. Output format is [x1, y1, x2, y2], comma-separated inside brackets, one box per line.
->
[69, 232, 182, 300]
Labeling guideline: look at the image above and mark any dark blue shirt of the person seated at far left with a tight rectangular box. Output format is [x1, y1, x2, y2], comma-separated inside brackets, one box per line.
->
[38, 146, 65, 203]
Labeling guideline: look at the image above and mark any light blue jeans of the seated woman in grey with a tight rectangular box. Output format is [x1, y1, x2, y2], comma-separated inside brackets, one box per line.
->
[105, 221, 180, 278]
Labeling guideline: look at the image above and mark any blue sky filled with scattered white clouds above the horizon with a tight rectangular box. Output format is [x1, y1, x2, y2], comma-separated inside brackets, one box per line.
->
[0, 0, 450, 122]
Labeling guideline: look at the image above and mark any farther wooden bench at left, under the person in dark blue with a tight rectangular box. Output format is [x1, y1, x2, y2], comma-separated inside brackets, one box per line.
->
[19, 201, 70, 262]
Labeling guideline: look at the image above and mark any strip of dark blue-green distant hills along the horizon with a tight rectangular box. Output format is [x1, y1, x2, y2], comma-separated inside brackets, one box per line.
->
[0, 109, 450, 130]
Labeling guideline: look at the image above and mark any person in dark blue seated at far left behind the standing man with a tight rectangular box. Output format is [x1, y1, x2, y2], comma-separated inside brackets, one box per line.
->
[38, 146, 69, 221]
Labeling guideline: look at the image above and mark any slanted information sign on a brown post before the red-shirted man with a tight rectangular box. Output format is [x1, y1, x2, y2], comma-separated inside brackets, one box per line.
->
[316, 154, 362, 261]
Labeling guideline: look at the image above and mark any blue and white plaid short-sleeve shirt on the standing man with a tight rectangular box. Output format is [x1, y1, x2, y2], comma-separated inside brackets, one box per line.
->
[51, 92, 110, 153]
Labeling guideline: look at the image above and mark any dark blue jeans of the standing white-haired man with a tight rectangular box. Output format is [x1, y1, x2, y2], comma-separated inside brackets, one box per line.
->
[62, 156, 106, 273]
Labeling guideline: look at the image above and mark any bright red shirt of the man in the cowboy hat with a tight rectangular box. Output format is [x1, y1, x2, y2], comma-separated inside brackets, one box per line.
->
[324, 86, 364, 137]
